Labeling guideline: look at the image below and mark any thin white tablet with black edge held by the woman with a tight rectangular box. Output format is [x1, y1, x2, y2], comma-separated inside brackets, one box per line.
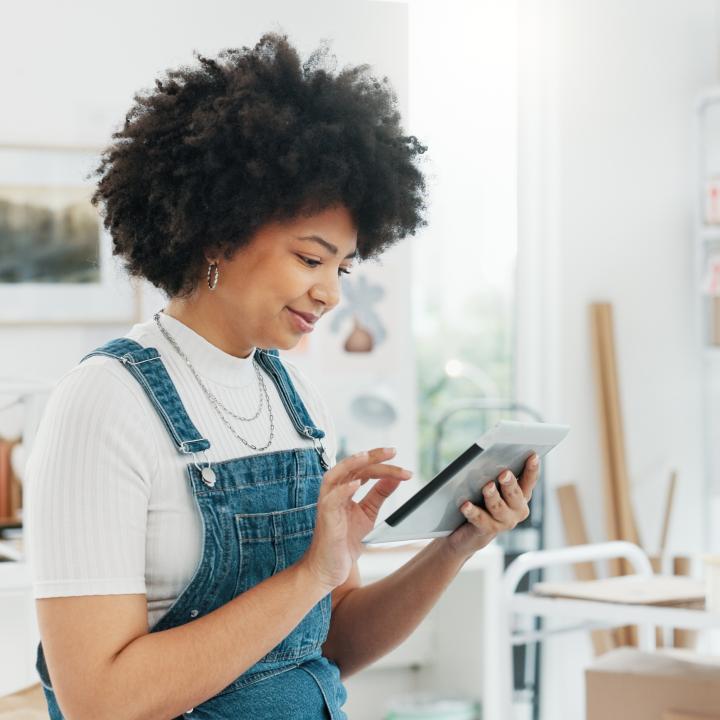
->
[362, 420, 570, 544]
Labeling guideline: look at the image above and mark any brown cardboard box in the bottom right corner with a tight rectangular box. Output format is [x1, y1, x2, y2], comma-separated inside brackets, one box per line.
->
[585, 647, 720, 720]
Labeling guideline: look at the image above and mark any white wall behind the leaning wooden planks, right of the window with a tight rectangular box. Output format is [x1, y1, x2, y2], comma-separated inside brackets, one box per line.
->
[517, 0, 720, 718]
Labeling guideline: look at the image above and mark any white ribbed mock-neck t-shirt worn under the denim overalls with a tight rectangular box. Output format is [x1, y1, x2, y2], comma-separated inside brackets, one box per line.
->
[25, 315, 336, 626]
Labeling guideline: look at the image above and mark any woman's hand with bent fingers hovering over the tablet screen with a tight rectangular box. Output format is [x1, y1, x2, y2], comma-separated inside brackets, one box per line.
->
[301, 448, 412, 591]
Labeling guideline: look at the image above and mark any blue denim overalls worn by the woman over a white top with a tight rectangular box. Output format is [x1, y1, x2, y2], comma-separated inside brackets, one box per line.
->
[36, 338, 347, 720]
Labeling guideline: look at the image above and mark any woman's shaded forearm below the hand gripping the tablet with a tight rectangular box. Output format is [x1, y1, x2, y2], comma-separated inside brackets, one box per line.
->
[323, 538, 467, 677]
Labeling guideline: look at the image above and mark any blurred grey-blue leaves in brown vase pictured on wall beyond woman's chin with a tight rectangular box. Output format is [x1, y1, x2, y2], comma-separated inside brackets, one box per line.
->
[331, 275, 386, 353]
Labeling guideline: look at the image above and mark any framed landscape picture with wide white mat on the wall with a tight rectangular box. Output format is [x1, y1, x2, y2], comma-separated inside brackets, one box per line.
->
[0, 145, 138, 324]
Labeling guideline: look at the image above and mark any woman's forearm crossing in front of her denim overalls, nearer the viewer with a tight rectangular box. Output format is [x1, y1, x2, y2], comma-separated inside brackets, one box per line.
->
[92, 563, 328, 720]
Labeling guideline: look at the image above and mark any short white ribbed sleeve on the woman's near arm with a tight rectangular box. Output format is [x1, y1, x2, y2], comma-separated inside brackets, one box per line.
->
[25, 357, 158, 598]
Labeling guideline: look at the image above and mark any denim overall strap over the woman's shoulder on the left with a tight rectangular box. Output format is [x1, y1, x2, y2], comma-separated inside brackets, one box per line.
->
[81, 338, 210, 455]
